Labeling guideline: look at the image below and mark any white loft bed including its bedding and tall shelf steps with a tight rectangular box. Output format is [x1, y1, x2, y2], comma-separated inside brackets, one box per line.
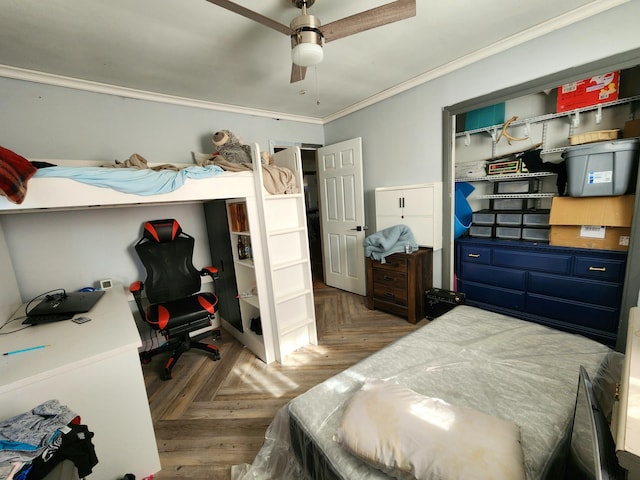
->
[0, 144, 317, 363]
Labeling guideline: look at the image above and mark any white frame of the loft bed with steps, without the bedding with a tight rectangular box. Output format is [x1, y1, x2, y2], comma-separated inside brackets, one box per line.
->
[0, 144, 317, 363]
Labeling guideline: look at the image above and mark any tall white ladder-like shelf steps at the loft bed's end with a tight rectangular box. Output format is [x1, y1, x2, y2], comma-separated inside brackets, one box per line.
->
[252, 147, 318, 363]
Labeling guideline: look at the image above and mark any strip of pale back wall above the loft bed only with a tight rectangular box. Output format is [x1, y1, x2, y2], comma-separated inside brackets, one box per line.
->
[0, 78, 324, 163]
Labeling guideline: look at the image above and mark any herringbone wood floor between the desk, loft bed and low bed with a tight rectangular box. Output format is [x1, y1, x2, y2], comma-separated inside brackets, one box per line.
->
[142, 287, 427, 480]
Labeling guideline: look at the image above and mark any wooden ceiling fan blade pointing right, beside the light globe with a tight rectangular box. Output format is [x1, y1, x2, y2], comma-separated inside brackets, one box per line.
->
[318, 0, 416, 42]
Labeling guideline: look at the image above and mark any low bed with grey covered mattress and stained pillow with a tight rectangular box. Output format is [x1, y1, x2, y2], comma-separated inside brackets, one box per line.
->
[232, 306, 623, 480]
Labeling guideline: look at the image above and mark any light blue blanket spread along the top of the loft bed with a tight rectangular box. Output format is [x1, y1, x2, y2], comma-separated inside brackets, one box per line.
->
[34, 165, 224, 195]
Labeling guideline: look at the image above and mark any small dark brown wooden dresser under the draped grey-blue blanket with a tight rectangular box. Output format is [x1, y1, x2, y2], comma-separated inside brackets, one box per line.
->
[366, 247, 433, 323]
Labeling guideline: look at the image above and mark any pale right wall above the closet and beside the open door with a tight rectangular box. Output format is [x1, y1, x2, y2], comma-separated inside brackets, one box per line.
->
[325, 0, 640, 285]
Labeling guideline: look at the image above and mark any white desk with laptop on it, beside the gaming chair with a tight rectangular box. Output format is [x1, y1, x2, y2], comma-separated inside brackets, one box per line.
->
[0, 285, 160, 480]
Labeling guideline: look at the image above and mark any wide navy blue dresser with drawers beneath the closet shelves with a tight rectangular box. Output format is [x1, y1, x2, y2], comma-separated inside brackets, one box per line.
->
[456, 238, 627, 346]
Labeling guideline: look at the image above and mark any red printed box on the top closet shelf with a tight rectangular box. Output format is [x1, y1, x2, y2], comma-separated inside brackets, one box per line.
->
[556, 70, 620, 112]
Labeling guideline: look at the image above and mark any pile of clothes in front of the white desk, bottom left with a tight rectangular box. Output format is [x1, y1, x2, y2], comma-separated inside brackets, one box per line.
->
[0, 400, 98, 480]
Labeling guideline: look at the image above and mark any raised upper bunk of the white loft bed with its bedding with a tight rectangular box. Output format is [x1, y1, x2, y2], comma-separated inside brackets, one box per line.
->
[0, 144, 296, 213]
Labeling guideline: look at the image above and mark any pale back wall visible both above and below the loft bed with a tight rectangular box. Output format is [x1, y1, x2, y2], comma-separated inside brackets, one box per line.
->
[0, 78, 324, 304]
